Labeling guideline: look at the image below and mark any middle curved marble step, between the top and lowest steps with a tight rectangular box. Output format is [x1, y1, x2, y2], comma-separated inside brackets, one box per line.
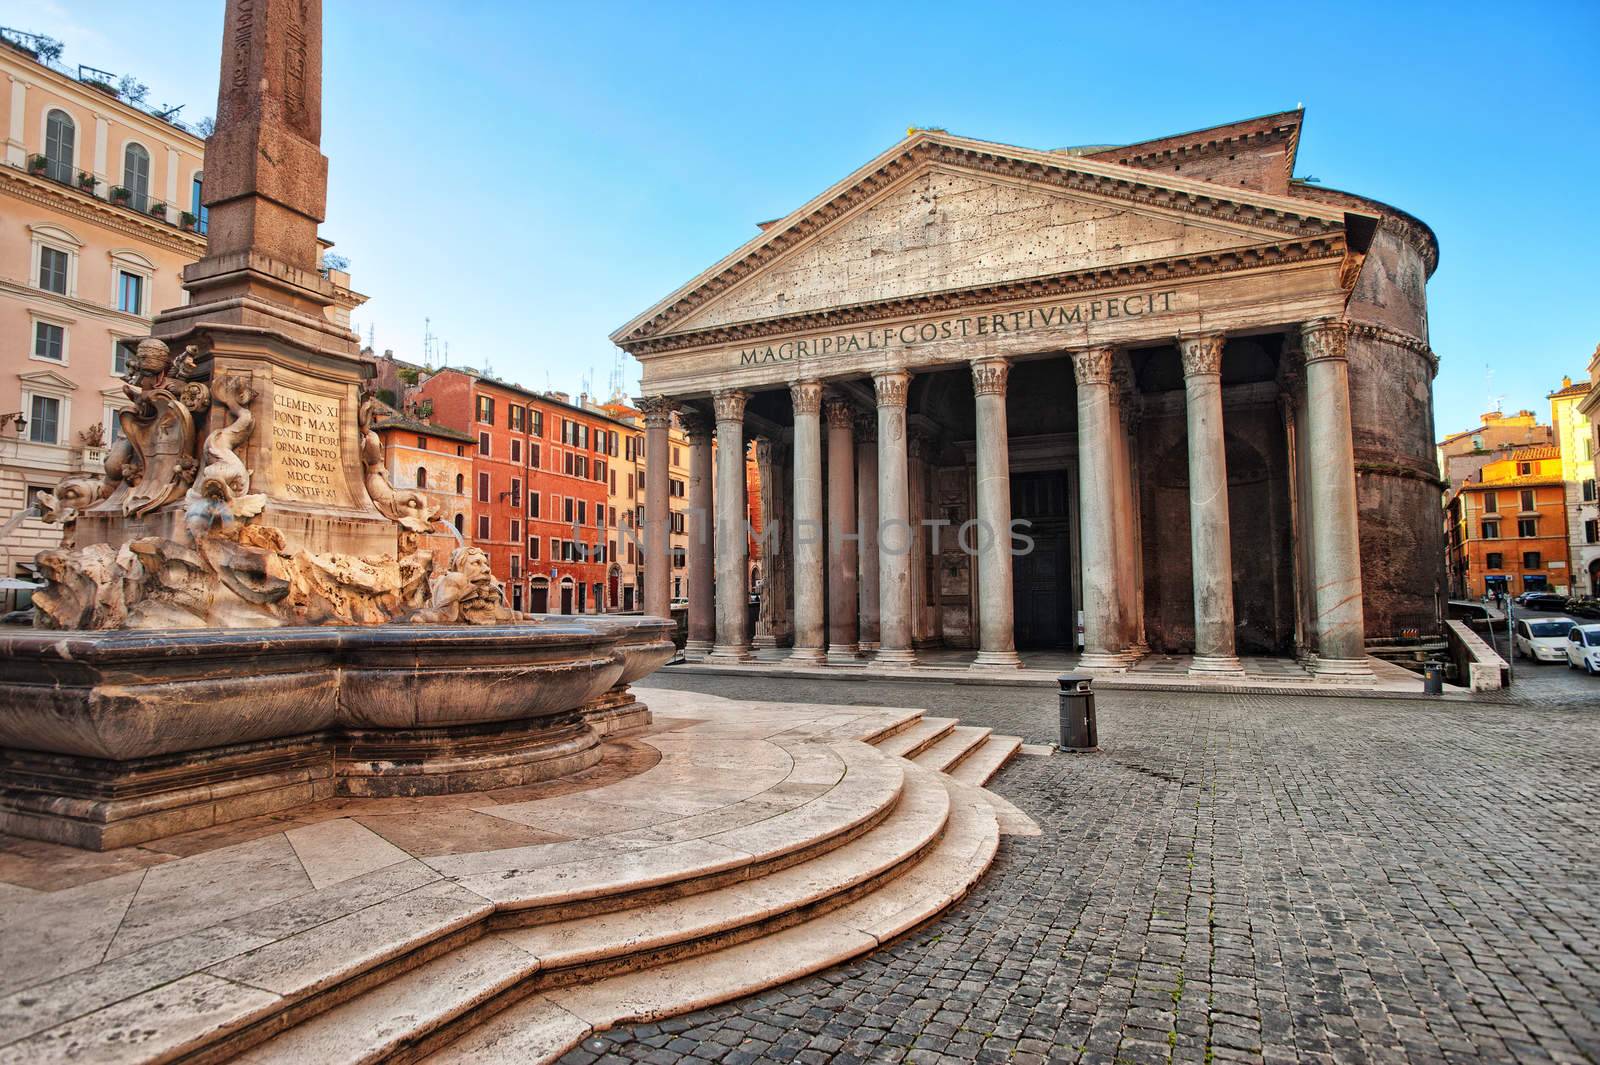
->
[237, 768, 953, 1065]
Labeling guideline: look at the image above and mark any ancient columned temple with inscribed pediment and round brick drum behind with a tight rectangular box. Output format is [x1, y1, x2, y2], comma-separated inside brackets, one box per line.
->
[613, 110, 1442, 678]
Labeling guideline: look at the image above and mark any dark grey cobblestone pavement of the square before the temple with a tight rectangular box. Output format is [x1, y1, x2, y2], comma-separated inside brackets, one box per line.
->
[566, 667, 1600, 1065]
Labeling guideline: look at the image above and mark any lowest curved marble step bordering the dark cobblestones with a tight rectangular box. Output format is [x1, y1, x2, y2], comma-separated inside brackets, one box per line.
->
[421, 770, 1000, 1065]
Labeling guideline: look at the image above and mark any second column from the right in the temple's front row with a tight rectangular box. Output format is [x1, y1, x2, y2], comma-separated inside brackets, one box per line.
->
[1182, 336, 1243, 673]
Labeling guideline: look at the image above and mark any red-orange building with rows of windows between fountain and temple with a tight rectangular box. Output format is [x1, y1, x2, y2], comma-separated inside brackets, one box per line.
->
[414, 369, 629, 614]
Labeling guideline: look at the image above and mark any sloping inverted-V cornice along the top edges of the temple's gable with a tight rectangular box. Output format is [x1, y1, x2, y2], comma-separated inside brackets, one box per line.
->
[611, 131, 1346, 353]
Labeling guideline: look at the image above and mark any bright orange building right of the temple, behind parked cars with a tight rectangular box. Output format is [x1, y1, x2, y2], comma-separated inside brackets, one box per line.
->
[1445, 446, 1571, 598]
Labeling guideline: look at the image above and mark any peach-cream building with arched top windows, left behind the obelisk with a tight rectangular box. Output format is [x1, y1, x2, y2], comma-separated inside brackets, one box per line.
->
[0, 45, 206, 588]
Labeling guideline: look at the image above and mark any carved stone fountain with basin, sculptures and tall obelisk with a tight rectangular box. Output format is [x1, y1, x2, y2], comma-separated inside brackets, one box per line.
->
[0, 0, 672, 849]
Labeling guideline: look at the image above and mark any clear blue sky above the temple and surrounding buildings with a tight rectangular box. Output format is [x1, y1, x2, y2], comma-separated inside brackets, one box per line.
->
[34, 0, 1600, 435]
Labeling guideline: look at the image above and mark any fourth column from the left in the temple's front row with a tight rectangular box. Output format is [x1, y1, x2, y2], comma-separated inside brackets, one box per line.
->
[872, 369, 917, 667]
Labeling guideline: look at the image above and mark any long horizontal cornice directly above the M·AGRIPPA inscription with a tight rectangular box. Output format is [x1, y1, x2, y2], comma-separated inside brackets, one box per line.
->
[619, 233, 1346, 357]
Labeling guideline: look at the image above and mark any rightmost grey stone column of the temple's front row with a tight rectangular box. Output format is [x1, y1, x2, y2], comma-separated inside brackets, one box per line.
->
[1301, 318, 1371, 676]
